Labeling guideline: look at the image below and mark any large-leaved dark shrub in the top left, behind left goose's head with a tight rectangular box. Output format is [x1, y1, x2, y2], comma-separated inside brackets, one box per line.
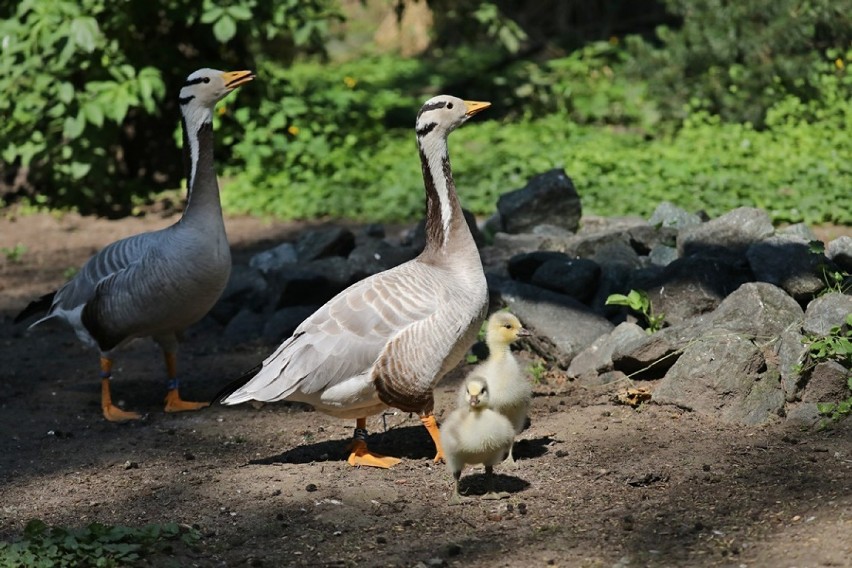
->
[0, 0, 340, 212]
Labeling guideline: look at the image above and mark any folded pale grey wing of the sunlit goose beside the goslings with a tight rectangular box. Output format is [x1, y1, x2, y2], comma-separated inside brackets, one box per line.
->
[223, 262, 444, 404]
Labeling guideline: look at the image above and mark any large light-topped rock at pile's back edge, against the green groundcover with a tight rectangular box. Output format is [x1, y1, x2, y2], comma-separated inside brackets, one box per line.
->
[677, 207, 775, 256]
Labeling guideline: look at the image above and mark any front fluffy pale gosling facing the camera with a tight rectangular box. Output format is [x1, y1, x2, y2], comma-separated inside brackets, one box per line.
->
[441, 376, 515, 505]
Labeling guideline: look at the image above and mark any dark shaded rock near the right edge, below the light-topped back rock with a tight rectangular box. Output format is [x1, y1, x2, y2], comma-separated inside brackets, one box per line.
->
[746, 236, 827, 302]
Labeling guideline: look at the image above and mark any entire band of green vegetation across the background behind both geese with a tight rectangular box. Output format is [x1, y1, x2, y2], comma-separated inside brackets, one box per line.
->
[0, 0, 852, 224]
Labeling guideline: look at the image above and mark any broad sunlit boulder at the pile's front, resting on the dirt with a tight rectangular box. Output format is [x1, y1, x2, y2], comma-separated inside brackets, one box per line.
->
[653, 334, 784, 425]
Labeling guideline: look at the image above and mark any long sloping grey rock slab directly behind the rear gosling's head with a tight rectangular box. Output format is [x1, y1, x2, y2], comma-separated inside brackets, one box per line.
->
[488, 275, 613, 359]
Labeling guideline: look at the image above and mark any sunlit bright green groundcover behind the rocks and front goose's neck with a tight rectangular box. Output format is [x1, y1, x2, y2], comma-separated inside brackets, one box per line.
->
[223, 49, 852, 224]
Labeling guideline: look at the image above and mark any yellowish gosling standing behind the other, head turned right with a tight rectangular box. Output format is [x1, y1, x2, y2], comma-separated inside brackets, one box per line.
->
[459, 312, 532, 465]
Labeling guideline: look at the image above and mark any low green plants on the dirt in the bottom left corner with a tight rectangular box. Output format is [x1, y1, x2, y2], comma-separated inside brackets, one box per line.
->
[0, 519, 200, 568]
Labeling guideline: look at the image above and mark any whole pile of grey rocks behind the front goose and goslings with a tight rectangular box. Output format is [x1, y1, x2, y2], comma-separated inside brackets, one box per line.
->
[211, 170, 852, 424]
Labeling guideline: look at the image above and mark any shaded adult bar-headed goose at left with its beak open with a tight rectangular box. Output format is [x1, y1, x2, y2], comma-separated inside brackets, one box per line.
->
[15, 69, 254, 421]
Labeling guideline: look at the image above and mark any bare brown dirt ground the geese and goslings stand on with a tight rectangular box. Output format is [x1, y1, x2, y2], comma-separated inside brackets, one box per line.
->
[0, 215, 852, 568]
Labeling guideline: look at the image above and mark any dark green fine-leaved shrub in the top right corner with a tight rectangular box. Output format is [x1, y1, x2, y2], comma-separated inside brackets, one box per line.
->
[629, 0, 852, 127]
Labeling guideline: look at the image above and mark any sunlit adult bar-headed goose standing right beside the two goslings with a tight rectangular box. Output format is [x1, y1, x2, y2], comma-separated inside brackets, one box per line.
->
[223, 95, 490, 467]
